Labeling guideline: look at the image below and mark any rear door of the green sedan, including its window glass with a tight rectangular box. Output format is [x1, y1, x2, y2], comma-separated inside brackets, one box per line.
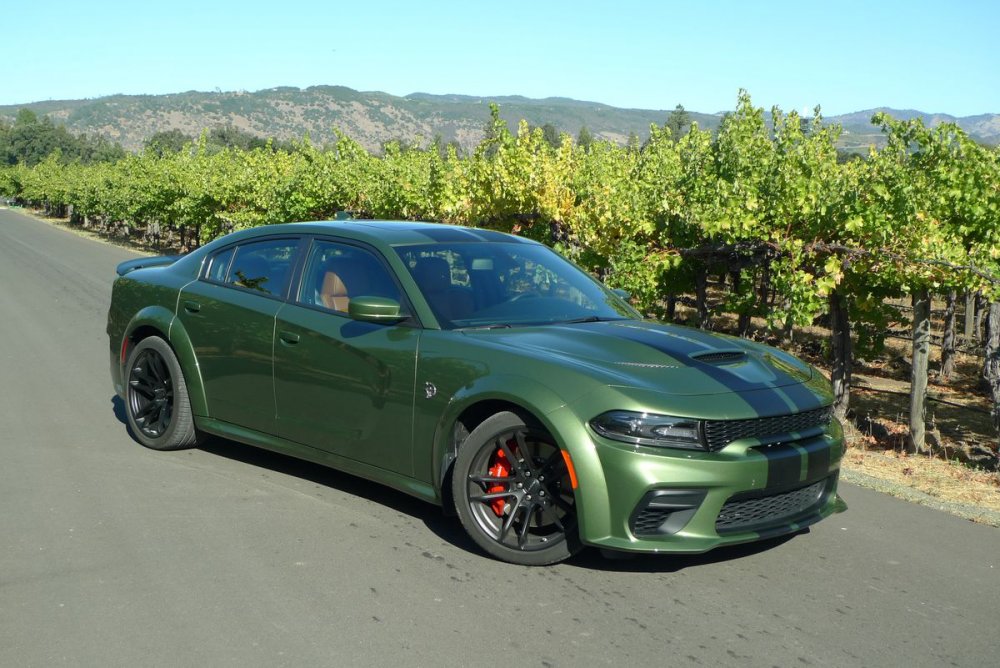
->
[178, 238, 301, 434]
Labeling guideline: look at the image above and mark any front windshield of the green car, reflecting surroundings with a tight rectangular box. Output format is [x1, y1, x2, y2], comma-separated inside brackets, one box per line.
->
[396, 241, 639, 329]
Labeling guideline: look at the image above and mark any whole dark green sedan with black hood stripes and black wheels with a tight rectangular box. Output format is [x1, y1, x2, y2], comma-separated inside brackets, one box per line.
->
[107, 221, 846, 565]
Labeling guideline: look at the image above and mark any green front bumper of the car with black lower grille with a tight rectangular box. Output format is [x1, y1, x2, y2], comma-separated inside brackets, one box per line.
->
[548, 410, 847, 553]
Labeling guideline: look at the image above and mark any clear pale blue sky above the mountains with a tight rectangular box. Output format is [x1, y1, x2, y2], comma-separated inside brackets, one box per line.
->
[0, 0, 1000, 116]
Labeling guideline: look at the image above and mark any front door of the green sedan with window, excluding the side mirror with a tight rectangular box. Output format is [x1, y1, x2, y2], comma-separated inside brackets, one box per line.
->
[274, 239, 420, 475]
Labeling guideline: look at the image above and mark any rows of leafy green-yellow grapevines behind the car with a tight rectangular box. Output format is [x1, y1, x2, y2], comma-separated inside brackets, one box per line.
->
[0, 92, 1000, 468]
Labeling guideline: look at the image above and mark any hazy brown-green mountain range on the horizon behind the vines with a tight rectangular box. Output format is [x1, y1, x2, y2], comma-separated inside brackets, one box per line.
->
[0, 86, 1000, 151]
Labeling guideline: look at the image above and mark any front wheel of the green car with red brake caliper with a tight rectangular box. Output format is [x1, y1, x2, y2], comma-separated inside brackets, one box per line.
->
[452, 412, 582, 566]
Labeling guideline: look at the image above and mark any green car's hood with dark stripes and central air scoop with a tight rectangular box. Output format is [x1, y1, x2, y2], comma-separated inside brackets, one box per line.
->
[466, 320, 813, 396]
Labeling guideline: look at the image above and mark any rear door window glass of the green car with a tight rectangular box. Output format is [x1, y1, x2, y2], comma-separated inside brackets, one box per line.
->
[205, 239, 299, 296]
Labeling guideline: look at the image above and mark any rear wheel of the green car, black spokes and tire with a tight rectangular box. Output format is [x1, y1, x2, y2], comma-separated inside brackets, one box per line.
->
[125, 336, 199, 450]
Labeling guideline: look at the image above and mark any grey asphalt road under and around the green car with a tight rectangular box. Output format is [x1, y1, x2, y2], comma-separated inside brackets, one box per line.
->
[0, 210, 1000, 667]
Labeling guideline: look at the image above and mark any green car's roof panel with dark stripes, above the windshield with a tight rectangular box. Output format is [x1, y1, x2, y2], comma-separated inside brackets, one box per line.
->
[232, 220, 536, 246]
